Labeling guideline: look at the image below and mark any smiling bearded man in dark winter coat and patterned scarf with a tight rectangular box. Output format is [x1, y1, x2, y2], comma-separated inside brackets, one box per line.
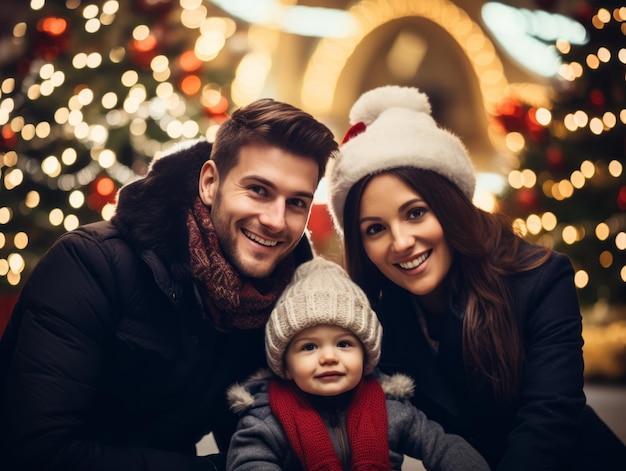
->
[0, 99, 337, 471]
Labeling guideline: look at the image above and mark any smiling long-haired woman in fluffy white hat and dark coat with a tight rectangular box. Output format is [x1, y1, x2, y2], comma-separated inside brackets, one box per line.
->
[329, 86, 626, 471]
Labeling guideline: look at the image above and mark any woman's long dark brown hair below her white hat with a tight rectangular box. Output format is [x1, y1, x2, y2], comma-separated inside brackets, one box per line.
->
[344, 167, 549, 401]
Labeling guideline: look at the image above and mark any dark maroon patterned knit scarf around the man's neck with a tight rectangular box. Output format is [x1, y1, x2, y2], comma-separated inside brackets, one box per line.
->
[187, 197, 295, 332]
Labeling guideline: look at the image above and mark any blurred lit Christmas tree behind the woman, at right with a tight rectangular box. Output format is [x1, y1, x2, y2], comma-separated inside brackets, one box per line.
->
[498, 0, 626, 307]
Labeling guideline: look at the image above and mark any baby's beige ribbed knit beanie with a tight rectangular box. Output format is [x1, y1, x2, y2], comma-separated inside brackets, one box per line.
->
[265, 257, 382, 378]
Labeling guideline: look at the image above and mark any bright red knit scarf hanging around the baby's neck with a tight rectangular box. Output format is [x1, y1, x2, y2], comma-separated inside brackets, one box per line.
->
[269, 378, 391, 471]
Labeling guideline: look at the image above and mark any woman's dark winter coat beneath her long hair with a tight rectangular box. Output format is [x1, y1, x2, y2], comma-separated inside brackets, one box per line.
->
[377, 249, 626, 471]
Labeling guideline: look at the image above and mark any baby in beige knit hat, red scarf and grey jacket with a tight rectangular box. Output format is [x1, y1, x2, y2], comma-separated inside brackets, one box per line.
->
[227, 257, 489, 471]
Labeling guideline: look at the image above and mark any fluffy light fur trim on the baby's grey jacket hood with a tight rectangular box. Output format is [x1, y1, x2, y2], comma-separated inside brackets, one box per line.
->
[226, 369, 415, 414]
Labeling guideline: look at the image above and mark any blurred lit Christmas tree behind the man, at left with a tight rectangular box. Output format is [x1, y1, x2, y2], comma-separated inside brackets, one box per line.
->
[0, 0, 245, 295]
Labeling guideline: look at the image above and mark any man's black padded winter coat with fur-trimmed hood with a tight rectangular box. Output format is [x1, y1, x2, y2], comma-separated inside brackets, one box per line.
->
[0, 142, 312, 471]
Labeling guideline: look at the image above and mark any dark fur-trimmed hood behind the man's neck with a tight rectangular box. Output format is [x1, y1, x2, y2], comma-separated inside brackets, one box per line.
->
[112, 139, 212, 274]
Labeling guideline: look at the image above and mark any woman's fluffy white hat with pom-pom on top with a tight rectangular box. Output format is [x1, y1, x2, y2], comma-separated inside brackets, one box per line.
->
[328, 85, 476, 233]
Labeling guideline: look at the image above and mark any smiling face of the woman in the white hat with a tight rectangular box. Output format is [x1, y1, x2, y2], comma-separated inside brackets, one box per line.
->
[359, 174, 452, 296]
